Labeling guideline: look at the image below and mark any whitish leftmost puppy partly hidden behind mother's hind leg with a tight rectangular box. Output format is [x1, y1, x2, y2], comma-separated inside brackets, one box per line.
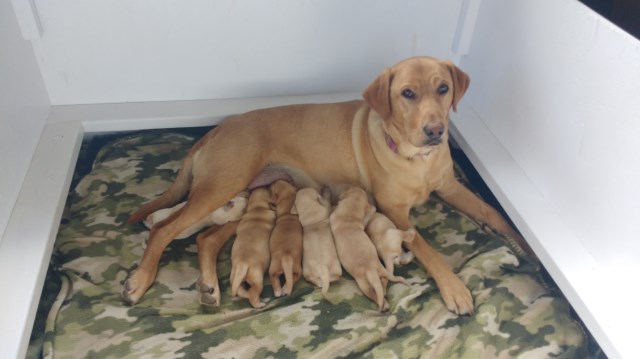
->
[143, 191, 249, 239]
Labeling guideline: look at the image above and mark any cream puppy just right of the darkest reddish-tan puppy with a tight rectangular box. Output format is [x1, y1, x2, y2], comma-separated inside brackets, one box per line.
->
[294, 188, 342, 294]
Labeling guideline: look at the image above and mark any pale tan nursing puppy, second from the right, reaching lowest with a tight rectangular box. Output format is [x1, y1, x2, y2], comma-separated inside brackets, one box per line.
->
[329, 187, 390, 312]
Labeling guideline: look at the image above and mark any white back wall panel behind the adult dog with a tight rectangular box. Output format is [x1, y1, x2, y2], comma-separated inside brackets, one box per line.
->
[34, 0, 462, 105]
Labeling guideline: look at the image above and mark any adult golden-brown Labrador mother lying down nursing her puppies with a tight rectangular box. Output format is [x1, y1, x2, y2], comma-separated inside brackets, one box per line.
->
[123, 57, 521, 314]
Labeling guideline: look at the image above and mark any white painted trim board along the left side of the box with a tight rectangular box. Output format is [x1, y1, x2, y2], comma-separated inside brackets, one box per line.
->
[0, 122, 83, 358]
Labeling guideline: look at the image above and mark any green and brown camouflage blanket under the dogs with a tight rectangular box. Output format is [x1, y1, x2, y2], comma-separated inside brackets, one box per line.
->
[35, 132, 590, 358]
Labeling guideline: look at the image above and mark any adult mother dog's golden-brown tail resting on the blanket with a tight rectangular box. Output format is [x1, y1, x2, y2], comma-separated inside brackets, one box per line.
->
[128, 155, 193, 224]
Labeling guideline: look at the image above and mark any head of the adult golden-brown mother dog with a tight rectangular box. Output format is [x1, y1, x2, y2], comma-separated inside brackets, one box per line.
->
[363, 57, 469, 158]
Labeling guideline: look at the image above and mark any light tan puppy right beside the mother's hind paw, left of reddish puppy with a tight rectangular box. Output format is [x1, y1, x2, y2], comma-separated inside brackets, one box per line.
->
[230, 187, 276, 308]
